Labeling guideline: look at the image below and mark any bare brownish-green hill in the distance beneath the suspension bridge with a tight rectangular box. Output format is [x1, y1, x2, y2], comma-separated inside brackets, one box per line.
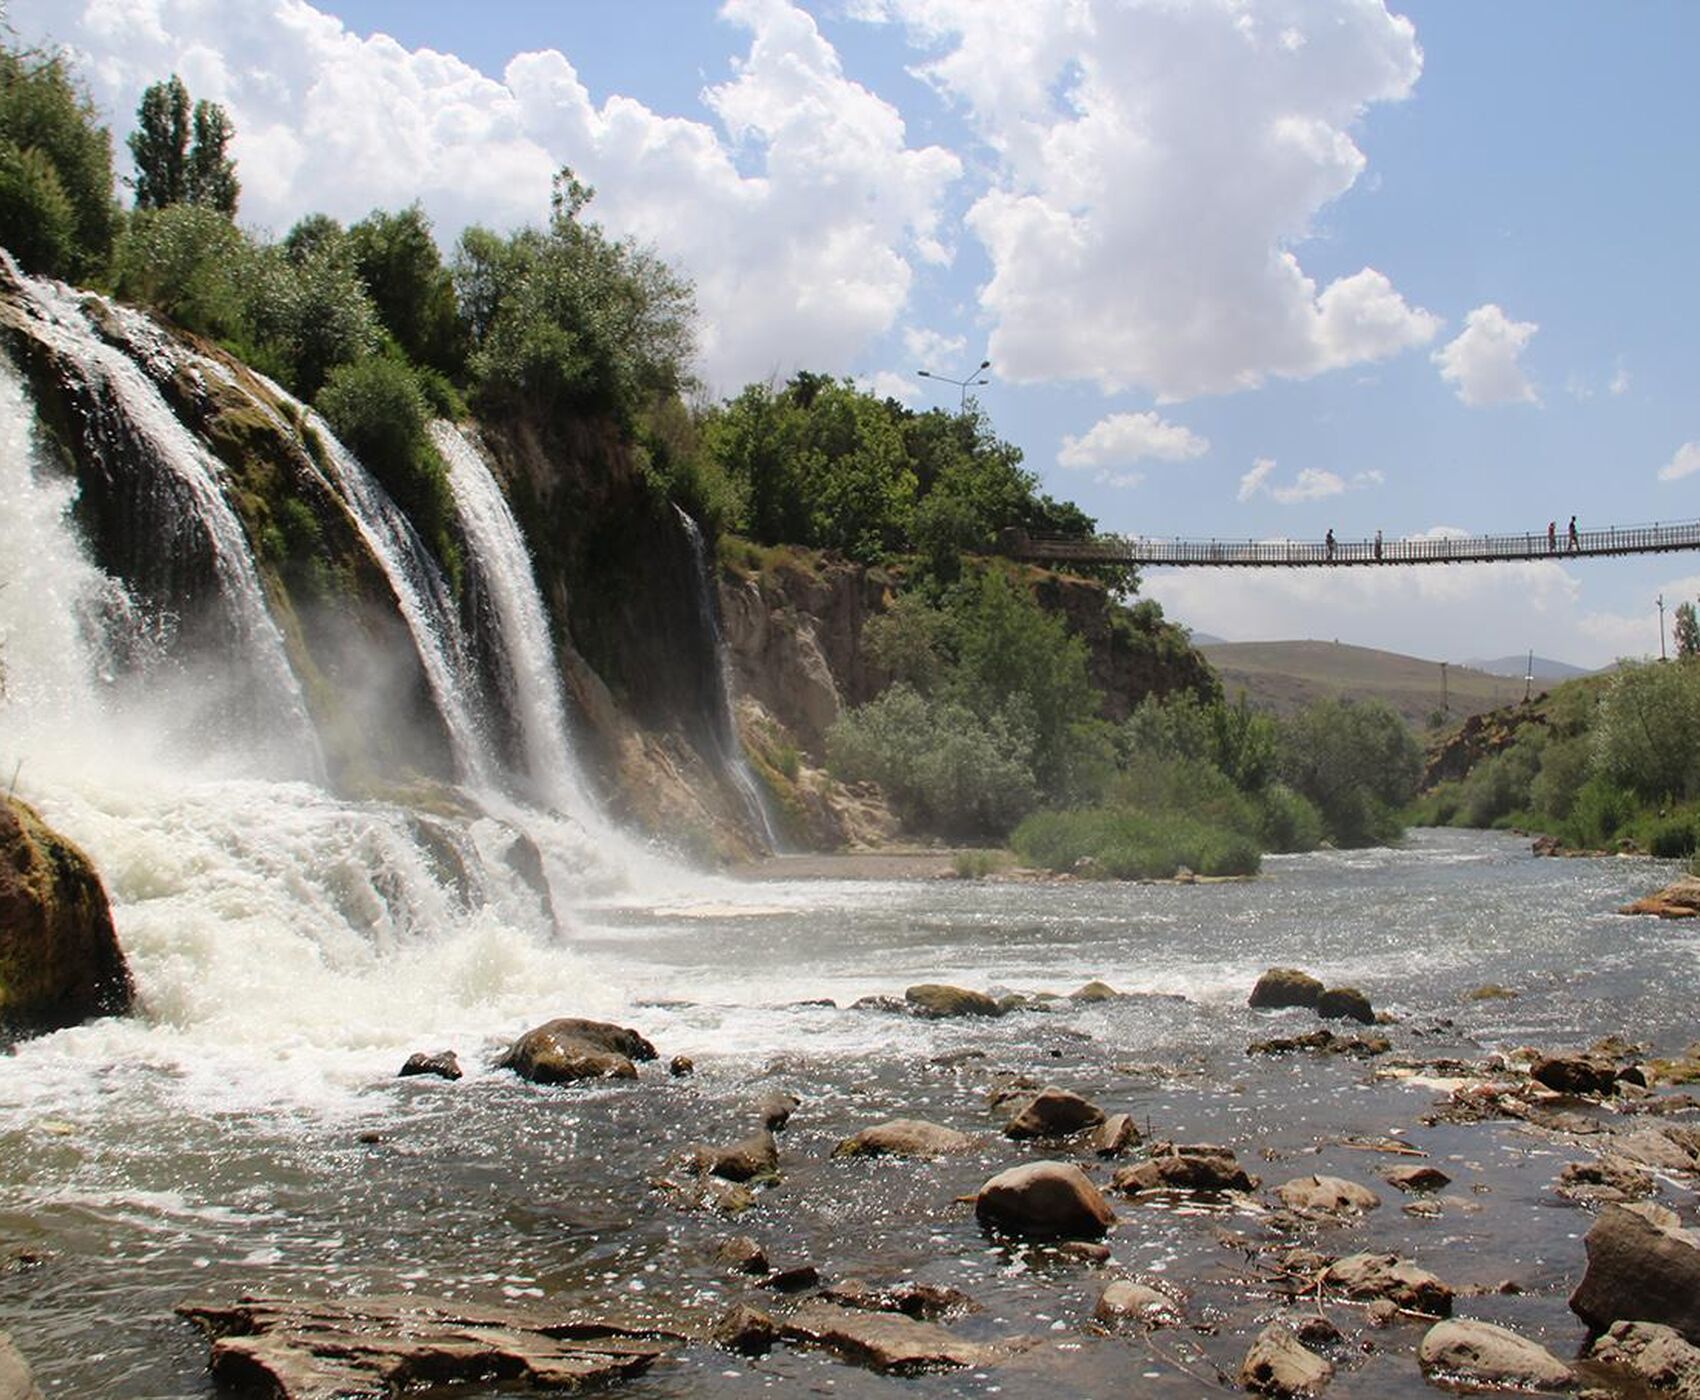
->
[1200, 642, 1543, 729]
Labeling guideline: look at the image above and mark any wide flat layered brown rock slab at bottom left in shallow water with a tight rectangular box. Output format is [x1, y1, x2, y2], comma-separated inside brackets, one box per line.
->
[177, 1296, 668, 1400]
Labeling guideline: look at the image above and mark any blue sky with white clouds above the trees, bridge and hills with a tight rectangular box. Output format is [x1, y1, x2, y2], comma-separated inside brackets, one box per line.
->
[10, 0, 1700, 664]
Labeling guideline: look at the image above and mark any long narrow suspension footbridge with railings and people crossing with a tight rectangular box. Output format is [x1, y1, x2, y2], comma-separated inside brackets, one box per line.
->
[1003, 520, 1700, 569]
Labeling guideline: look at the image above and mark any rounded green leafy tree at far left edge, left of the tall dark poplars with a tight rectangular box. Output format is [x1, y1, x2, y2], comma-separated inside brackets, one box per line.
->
[0, 49, 119, 280]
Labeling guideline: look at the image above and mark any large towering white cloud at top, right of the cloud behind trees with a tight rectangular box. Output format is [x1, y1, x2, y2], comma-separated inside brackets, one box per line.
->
[860, 0, 1440, 399]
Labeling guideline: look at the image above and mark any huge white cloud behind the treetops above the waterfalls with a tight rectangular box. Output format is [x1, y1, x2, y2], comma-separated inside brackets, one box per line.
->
[19, 0, 962, 387]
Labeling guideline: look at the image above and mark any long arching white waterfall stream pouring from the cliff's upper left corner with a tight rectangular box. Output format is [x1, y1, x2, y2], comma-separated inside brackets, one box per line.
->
[5, 270, 323, 775]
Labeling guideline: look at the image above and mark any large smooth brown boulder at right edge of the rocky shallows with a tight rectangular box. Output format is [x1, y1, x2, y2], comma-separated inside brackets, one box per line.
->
[1571, 1201, 1700, 1344]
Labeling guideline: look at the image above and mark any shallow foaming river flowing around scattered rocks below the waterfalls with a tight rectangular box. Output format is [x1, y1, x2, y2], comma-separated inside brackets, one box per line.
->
[0, 832, 1700, 1397]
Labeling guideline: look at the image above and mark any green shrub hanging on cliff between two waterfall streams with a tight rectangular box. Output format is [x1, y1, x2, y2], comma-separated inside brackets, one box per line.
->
[315, 355, 459, 578]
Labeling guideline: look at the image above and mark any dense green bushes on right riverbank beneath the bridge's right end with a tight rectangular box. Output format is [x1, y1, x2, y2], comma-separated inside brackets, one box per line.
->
[1411, 658, 1700, 860]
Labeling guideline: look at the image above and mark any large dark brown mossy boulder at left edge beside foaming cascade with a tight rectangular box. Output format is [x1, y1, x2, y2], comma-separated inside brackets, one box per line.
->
[0, 797, 134, 1036]
